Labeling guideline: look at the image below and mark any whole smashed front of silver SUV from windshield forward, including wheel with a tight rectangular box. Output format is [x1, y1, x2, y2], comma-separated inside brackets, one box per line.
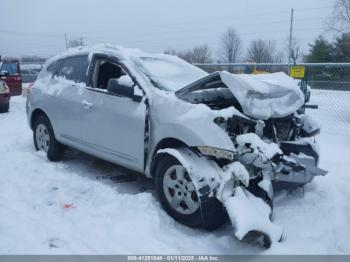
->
[135, 52, 326, 247]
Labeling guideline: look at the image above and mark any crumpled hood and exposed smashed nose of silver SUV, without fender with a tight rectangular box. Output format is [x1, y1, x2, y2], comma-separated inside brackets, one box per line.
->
[177, 73, 326, 189]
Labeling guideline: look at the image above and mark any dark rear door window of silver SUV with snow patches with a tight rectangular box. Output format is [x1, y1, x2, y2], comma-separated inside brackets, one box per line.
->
[57, 56, 89, 83]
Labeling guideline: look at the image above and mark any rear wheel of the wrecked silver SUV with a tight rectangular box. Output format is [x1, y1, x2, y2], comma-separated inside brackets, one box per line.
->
[33, 115, 65, 161]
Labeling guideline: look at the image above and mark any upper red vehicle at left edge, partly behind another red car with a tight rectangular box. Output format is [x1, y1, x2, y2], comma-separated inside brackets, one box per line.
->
[0, 60, 22, 96]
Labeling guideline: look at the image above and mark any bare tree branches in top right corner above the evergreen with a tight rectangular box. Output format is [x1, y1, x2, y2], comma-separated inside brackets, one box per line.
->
[326, 0, 350, 33]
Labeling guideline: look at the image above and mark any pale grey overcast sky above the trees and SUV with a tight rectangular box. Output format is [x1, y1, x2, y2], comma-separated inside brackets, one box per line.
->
[0, 0, 334, 59]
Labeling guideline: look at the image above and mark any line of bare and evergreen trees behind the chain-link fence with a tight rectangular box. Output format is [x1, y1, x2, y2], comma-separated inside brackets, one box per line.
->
[164, 0, 350, 63]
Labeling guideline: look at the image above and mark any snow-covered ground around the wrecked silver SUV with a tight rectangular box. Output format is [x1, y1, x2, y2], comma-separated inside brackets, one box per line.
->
[0, 91, 350, 254]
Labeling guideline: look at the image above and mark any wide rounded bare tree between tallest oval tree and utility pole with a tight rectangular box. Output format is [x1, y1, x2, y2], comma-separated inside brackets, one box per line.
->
[247, 39, 283, 63]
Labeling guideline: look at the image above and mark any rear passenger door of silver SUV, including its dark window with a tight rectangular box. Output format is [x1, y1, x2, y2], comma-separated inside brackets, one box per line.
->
[48, 55, 91, 149]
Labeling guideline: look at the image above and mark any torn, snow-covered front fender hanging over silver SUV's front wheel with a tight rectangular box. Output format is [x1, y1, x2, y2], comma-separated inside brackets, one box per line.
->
[157, 148, 283, 247]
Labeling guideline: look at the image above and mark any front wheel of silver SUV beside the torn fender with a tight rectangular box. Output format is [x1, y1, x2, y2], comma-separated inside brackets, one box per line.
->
[155, 154, 228, 230]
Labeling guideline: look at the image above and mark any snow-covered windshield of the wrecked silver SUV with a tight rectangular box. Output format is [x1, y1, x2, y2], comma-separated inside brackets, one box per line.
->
[139, 55, 207, 91]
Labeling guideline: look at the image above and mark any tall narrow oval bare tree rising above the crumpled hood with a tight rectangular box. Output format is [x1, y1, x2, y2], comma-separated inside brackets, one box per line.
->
[219, 27, 242, 63]
